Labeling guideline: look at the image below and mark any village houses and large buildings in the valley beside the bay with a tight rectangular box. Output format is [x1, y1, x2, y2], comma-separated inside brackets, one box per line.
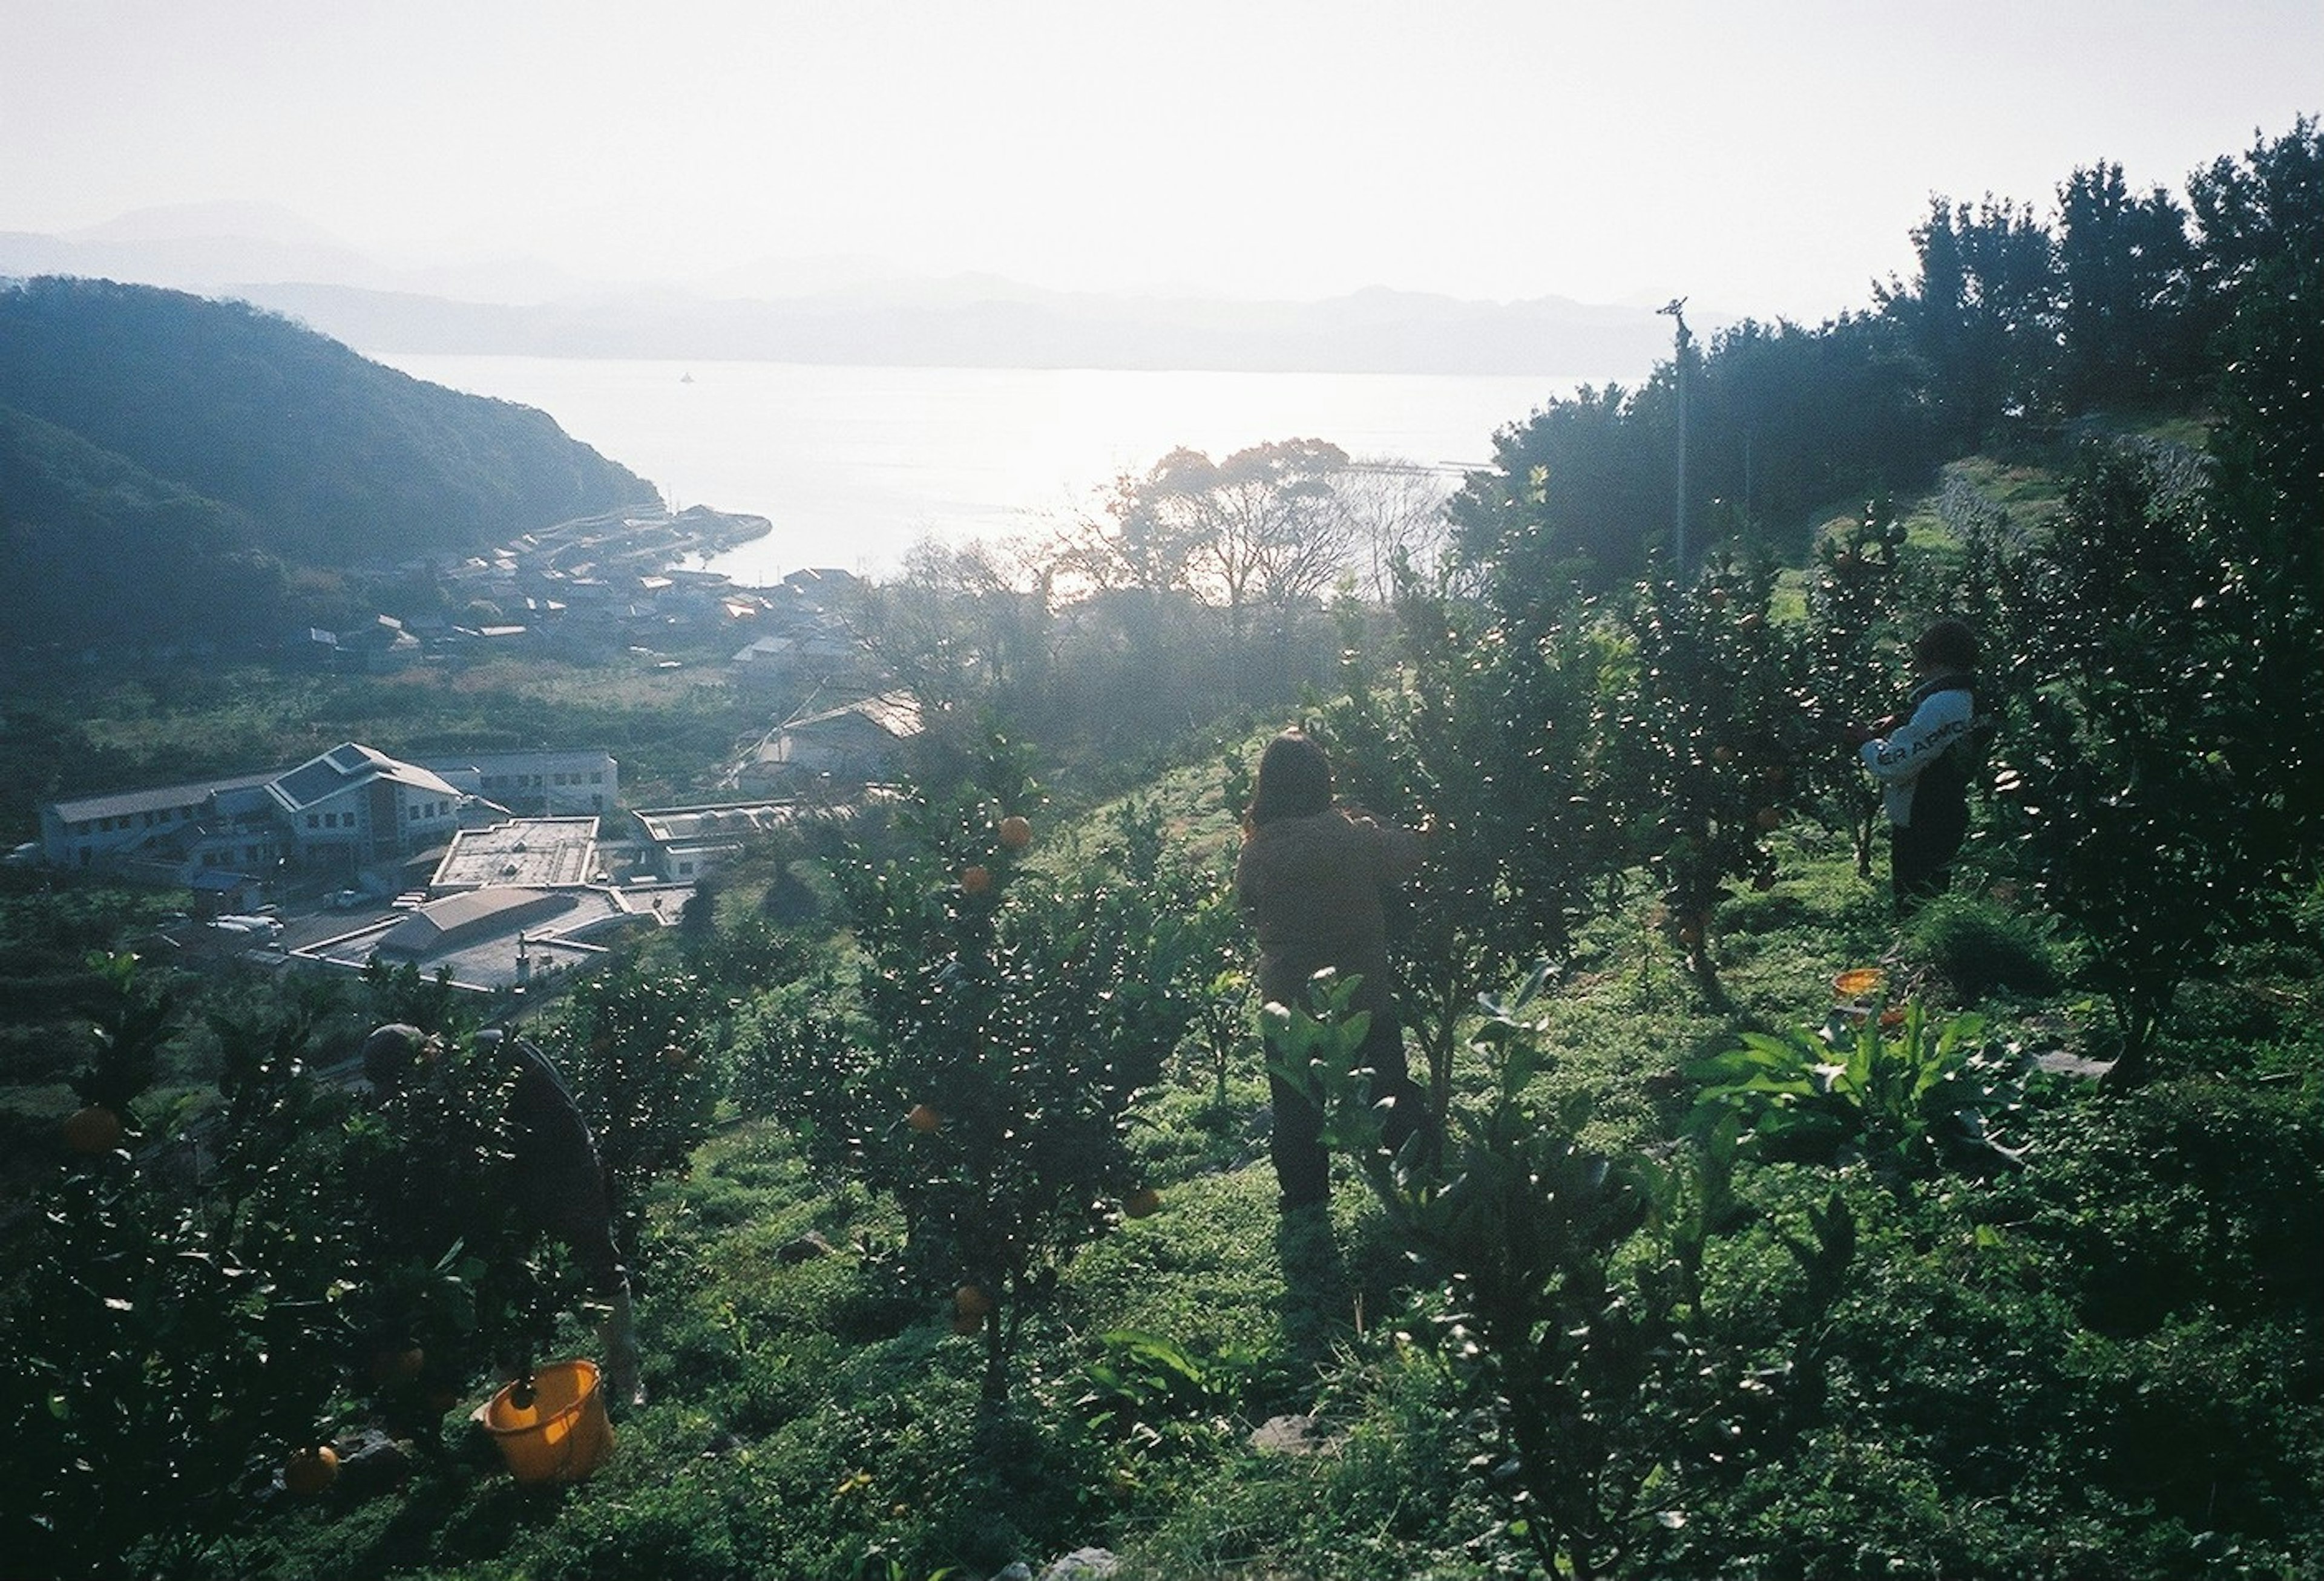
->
[22, 507, 921, 995]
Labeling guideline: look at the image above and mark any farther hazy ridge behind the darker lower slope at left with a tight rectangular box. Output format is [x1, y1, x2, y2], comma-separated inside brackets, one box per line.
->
[0, 277, 658, 567]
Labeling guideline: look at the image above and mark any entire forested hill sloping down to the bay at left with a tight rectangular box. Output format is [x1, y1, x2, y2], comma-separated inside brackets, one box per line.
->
[0, 279, 655, 642]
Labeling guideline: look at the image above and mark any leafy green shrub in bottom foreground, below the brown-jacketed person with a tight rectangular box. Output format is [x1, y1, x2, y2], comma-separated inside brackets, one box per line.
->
[1267, 967, 1775, 1579]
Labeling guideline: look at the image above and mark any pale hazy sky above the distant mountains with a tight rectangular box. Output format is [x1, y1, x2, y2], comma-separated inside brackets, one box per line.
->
[0, 0, 2324, 321]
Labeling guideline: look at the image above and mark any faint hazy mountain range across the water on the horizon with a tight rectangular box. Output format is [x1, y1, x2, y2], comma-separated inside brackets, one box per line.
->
[0, 205, 1671, 379]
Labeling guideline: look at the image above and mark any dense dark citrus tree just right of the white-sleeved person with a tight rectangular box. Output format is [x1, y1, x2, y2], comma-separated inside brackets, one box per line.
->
[2003, 449, 2286, 1084]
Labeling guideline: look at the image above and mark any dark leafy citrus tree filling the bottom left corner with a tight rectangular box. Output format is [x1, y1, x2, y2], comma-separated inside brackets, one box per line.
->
[0, 955, 346, 1576]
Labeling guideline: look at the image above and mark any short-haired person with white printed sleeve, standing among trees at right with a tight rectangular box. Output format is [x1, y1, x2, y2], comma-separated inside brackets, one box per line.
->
[1843, 621, 1994, 911]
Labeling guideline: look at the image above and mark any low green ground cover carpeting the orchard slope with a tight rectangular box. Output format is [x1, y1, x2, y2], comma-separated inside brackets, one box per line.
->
[190, 781, 2324, 1581]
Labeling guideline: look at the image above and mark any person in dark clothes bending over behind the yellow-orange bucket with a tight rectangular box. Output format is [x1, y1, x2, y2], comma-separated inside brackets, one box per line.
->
[363, 1023, 646, 1404]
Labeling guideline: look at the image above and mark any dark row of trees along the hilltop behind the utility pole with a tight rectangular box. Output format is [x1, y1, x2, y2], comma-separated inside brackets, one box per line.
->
[1452, 116, 2324, 602]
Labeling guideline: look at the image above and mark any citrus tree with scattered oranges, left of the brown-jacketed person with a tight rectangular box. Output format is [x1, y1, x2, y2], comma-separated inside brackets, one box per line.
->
[809, 753, 1201, 1399]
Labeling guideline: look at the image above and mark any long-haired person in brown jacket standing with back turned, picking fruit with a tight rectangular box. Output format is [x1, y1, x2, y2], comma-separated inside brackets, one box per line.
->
[1234, 730, 1425, 1211]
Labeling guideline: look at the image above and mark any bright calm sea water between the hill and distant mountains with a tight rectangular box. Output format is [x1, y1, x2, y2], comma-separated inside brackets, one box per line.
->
[381, 356, 1604, 586]
